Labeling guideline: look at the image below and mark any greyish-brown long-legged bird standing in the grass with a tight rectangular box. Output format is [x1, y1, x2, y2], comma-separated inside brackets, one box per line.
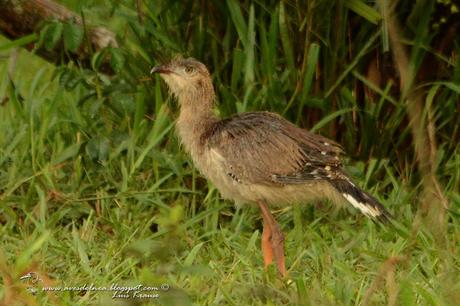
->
[150, 57, 391, 277]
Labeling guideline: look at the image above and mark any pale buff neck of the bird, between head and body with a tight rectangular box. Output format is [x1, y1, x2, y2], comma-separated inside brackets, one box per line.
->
[177, 93, 219, 158]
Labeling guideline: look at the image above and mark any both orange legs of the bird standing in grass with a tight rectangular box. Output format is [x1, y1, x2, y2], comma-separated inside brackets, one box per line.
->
[258, 202, 287, 277]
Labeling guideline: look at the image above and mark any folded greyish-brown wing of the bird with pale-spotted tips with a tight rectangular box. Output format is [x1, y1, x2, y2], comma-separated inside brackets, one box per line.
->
[203, 112, 342, 185]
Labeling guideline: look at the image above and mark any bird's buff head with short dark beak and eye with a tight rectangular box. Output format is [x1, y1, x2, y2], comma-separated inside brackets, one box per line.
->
[150, 58, 214, 100]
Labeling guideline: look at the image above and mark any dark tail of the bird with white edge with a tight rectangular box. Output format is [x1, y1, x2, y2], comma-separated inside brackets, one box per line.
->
[332, 178, 391, 222]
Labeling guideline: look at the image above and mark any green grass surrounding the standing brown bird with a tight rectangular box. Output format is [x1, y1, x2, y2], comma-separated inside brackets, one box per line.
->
[0, 0, 460, 305]
